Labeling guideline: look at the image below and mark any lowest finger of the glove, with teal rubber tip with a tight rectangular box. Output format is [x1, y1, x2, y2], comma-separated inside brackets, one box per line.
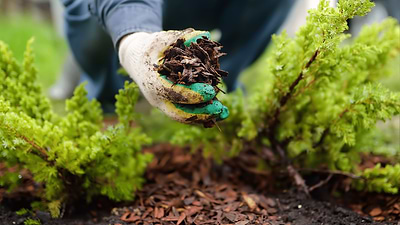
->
[174, 100, 229, 120]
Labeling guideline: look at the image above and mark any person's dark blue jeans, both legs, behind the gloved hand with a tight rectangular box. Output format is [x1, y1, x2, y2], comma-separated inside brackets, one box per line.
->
[65, 0, 294, 103]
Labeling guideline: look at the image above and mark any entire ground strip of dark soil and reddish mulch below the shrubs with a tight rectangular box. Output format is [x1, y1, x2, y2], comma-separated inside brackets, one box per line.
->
[0, 145, 400, 225]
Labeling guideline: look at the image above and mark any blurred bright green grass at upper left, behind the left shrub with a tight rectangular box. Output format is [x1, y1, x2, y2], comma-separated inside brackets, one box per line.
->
[0, 15, 67, 91]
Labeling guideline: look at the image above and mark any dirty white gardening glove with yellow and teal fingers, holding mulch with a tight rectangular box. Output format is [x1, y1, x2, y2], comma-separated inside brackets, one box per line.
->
[119, 29, 229, 124]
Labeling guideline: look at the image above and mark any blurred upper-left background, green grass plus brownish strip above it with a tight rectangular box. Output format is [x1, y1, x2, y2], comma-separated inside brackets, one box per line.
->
[0, 0, 67, 93]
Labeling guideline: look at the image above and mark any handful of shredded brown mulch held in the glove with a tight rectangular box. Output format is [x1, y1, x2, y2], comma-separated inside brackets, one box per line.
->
[157, 36, 228, 89]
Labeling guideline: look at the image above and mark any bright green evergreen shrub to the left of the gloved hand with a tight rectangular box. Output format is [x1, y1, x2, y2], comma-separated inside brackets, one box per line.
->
[0, 40, 152, 217]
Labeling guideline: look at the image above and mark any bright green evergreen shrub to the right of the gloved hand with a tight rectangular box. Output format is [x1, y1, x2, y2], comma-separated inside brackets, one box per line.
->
[173, 0, 400, 193]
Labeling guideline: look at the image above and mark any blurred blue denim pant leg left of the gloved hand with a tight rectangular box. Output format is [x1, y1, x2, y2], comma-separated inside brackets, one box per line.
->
[64, 0, 125, 107]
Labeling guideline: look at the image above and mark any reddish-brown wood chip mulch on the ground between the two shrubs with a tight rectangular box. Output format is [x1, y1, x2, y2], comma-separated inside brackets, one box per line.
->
[113, 146, 285, 225]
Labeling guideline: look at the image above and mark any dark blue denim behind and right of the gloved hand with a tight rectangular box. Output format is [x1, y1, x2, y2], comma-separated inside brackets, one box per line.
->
[163, 0, 295, 91]
